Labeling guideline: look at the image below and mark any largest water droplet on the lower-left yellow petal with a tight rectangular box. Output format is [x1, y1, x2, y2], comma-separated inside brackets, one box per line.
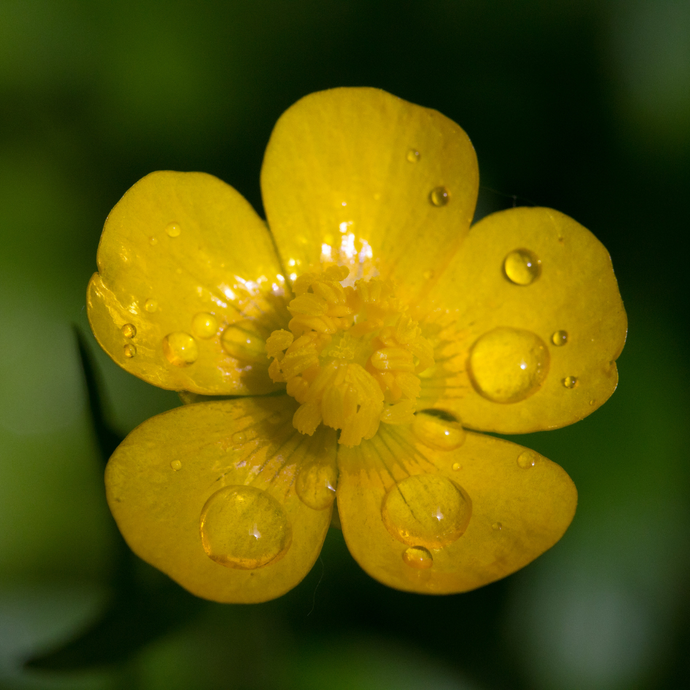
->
[200, 486, 292, 570]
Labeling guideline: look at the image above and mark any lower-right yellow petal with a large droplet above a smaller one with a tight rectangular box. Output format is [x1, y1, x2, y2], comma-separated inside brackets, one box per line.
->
[338, 420, 577, 594]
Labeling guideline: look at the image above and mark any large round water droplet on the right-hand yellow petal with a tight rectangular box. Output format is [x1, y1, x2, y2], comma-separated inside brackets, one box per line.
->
[468, 327, 549, 403]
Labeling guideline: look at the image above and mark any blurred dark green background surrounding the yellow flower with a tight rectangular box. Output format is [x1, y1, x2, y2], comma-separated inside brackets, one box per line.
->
[0, 0, 690, 690]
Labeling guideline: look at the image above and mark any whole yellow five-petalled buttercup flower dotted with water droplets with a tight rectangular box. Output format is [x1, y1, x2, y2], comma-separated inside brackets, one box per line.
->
[87, 88, 626, 602]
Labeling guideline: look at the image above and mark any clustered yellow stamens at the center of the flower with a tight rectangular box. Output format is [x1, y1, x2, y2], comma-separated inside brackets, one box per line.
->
[266, 266, 434, 446]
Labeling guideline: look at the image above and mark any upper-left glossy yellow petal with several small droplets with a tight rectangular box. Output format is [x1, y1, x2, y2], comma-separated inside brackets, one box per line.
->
[87, 172, 290, 395]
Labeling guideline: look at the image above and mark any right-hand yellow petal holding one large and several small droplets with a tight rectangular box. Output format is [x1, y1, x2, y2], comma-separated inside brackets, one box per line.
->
[417, 208, 627, 433]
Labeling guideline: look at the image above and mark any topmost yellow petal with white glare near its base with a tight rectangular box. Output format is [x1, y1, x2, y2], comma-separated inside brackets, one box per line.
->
[261, 88, 478, 296]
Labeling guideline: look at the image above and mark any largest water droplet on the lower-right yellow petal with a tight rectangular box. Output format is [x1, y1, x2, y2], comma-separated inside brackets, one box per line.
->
[381, 474, 472, 549]
